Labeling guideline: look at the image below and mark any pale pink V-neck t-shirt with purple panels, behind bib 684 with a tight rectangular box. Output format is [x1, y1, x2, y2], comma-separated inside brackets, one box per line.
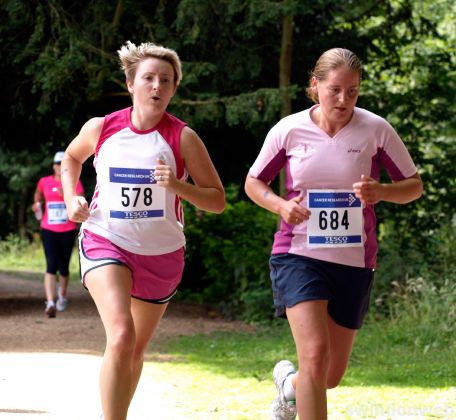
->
[250, 105, 417, 268]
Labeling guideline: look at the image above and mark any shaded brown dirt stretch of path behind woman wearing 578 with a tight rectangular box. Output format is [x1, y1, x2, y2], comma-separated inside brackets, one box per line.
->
[0, 273, 248, 356]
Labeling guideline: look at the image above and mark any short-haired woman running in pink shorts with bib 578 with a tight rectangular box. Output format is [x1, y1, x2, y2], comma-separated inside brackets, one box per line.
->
[62, 42, 225, 420]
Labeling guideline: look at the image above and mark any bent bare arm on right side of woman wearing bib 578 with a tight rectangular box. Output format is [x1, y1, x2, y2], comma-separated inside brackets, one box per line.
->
[155, 127, 225, 213]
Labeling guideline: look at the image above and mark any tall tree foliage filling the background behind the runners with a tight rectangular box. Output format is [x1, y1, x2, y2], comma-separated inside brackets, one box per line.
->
[0, 0, 456, 318]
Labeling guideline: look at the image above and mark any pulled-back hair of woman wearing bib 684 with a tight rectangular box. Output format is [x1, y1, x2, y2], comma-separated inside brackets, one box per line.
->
[306, 48, 362, 103]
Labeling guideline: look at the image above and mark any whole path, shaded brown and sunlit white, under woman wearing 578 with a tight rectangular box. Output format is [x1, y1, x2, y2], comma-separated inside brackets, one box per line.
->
[0, 274, 248, 420]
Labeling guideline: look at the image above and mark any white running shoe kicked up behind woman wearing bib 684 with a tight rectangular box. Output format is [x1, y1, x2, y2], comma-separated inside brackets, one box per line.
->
[271, 360, 296, 420]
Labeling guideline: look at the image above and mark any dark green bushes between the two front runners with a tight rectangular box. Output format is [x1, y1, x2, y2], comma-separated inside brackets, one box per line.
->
[182, 186, 277, 321]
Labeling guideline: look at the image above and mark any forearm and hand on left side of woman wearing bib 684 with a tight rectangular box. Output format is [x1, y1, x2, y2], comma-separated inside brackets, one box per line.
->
[245, 174, 310, 225]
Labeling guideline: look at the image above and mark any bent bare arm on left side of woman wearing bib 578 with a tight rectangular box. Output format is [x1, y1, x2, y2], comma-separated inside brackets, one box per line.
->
[61, 118, 104, 223]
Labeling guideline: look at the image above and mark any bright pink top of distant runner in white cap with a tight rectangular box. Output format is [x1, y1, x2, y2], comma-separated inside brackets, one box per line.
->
[38, 175, 84, 232]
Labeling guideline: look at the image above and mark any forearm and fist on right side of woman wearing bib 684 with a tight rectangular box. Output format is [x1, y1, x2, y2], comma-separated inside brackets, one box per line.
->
[353, 173, 423, 204]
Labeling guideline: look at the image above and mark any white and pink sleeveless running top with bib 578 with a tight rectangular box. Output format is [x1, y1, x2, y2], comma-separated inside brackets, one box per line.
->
[82, 107, 187, 255]
